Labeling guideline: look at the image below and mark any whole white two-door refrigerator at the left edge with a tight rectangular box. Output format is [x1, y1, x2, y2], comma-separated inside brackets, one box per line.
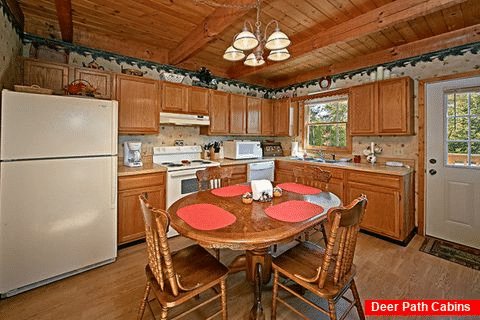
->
[0, 90, 118, 297]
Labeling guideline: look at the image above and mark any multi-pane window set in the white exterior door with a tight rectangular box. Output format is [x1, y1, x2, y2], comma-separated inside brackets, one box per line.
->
[445, 88, 480, 168]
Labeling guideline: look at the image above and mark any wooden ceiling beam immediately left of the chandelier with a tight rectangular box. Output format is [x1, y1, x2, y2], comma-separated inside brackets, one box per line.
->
[168, 0, 252, 65]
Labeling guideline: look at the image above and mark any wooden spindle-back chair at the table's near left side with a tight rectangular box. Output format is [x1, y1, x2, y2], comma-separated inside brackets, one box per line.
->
[138, 195, 228, 320]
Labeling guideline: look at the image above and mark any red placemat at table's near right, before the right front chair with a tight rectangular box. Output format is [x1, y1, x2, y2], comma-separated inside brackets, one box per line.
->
[265, 200, 323, 222]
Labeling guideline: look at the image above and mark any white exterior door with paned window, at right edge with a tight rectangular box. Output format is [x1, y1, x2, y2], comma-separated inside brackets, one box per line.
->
[426, 77, 480, 249]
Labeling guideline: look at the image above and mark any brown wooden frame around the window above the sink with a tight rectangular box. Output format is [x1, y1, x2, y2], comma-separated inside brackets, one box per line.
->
[302, 89, 352, 153]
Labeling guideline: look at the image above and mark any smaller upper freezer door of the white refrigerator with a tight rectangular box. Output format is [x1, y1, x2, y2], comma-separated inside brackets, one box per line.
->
[1, 90, 118, 160]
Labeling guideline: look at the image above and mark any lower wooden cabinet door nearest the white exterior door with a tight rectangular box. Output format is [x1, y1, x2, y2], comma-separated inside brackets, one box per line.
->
[346, 182, 403, 240]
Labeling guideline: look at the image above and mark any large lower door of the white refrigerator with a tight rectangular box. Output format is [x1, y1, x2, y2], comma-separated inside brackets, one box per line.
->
[0, 156, 117, 293]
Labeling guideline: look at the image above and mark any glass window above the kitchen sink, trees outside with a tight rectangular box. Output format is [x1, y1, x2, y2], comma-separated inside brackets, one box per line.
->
[305, 96, 350, 151]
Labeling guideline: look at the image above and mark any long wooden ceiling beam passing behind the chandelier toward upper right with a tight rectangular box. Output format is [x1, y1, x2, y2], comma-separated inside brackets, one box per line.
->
[227, 0, 467, 79]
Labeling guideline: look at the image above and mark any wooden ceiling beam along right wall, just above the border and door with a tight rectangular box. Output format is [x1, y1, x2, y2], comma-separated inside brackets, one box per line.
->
[268, 24, 480, 88]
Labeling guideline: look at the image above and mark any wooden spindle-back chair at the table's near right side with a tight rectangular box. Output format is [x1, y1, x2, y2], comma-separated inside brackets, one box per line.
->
[272, 195, 367, 319]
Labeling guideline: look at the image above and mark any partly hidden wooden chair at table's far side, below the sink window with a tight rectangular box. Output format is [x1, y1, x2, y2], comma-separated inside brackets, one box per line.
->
[293, 166, 332, 245]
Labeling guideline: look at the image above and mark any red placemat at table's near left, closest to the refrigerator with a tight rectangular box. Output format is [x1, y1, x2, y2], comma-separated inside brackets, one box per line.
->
[177, 203, 237, 230]
